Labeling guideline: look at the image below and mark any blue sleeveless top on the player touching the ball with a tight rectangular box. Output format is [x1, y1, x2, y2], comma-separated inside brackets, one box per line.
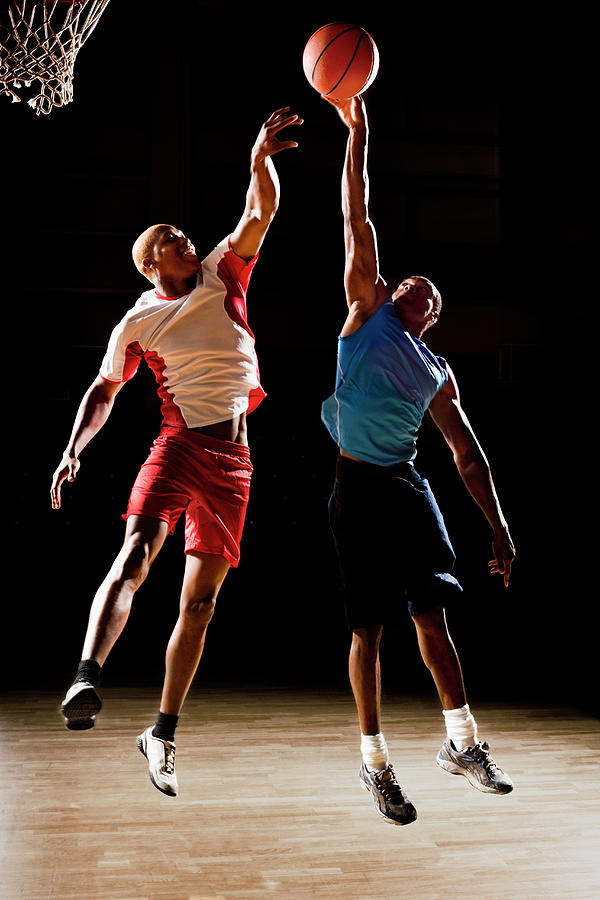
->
[321, 300, 448, 466]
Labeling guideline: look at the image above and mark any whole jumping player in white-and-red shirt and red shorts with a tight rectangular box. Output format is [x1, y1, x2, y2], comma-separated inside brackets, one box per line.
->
[51, 107, 302, 796]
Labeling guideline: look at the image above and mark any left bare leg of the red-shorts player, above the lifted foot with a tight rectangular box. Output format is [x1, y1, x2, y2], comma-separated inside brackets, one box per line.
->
[82, 516, 169, 666]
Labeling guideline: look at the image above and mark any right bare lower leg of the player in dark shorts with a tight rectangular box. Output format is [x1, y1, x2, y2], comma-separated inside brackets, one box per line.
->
[413, 607, 467, 709]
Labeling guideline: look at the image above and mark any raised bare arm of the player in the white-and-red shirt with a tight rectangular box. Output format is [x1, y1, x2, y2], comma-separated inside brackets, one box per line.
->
[231, 106, 303, 259]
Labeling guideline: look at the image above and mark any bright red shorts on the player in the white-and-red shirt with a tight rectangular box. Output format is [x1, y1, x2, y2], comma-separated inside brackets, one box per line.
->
[123, 426, 252, 566]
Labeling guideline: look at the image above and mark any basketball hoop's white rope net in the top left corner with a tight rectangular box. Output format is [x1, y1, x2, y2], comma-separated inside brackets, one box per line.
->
[0, 0, 109, 116]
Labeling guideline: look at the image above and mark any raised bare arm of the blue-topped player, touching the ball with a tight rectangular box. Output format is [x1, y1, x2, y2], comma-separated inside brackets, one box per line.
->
[324, 97, 388, 336]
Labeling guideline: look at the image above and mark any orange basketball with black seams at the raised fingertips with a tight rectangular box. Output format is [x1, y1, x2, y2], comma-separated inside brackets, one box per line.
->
[302, 22, 379, 100]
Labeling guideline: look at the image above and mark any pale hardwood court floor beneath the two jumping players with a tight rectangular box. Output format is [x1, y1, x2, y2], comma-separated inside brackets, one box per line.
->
[0, 687, 600, 900]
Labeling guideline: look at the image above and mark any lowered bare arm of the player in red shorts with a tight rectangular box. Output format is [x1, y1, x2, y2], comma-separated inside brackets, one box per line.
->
[50, 375, 123, 509]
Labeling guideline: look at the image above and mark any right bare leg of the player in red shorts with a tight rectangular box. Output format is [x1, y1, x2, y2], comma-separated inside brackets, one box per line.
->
[160, 553, 229, 716]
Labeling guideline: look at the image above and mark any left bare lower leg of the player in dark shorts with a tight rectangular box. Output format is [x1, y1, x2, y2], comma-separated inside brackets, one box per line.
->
[348, 625, 383, 734]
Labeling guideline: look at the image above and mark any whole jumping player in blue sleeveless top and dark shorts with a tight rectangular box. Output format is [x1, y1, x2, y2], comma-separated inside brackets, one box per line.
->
[322, 91, 515, 825]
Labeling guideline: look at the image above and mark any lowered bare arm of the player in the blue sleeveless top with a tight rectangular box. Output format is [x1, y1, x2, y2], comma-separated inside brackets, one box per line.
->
[429, 369, 515, 587]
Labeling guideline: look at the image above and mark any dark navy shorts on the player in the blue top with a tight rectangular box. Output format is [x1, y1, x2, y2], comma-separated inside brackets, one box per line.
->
[329, 455, 462, 628]
